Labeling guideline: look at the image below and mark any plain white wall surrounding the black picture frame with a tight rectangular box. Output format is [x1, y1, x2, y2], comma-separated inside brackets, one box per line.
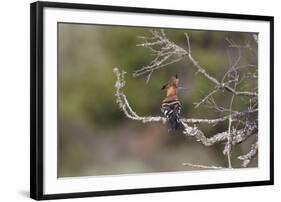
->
[0, 0, 276, 202]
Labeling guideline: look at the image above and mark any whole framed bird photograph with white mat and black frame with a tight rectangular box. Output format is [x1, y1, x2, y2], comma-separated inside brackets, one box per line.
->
[30, 2, 274, 200]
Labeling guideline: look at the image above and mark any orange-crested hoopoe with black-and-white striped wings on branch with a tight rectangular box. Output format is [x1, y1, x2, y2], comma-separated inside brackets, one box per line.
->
[161, 75, 182, 131]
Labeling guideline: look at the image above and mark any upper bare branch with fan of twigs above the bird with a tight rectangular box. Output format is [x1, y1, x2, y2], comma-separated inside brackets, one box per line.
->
[133, 30, 258, 96]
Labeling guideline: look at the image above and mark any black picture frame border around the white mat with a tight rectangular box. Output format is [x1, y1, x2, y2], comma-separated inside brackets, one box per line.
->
[30, 2, 274, 200]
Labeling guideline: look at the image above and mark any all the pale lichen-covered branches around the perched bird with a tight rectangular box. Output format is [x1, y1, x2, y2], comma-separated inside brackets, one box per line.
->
[114, 30, 258, 169]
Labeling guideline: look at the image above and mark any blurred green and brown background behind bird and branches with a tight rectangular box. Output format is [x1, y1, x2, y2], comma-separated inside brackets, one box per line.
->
[58, 23, 258, 177]
